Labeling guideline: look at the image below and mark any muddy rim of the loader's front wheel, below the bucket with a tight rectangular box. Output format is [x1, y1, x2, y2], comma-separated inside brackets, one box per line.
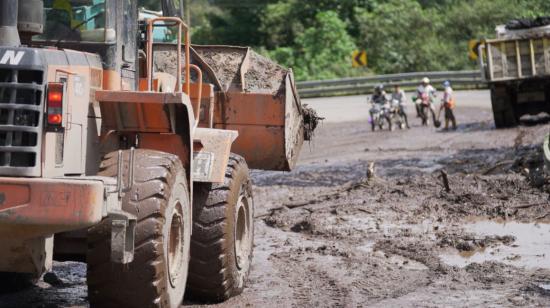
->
[235, 193, 251, 270]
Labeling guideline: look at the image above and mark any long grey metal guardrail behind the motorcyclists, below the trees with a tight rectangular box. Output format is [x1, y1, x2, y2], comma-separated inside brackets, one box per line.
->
[297, 70, 484, 97]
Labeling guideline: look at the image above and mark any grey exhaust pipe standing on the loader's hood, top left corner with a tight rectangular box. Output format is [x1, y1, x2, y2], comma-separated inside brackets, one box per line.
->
[0, 0, 21, 47]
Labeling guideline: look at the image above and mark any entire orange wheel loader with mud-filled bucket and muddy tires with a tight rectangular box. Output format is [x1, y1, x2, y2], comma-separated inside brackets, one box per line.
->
[0, 0, 316, 307]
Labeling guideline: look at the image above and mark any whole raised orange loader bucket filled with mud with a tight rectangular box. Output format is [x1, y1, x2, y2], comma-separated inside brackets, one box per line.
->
[193, 46, 316, 171]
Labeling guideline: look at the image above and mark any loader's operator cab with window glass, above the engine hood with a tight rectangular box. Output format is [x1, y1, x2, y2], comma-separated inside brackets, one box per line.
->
[32, 0, 138, 90]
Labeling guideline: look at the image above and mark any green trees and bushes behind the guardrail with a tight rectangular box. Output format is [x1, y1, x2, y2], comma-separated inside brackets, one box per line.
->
[184, 0, 550, 80]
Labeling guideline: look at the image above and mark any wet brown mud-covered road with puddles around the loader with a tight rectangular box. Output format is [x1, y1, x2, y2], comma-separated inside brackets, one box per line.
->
[0, 91, 550, 307]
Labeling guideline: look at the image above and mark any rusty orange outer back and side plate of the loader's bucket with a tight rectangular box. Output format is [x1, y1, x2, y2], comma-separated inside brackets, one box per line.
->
[214, 74, 304, 171]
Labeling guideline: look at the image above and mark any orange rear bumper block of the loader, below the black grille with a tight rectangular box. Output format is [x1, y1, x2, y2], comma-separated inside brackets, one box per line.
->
[0, 178, 104, 239]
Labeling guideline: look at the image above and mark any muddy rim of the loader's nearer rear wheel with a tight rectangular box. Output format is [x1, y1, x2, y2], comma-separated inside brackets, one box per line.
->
[168, 202, 185, 288]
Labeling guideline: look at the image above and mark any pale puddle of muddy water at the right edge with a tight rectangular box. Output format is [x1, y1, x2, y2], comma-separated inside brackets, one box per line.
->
[440, 221, 550, 268]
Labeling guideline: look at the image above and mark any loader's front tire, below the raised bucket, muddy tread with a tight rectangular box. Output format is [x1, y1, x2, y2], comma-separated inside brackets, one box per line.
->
[187, 154, 254, 302]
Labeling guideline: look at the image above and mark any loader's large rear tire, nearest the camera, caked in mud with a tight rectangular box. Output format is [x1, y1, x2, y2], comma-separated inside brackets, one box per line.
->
[87, 150, 192, 308]
